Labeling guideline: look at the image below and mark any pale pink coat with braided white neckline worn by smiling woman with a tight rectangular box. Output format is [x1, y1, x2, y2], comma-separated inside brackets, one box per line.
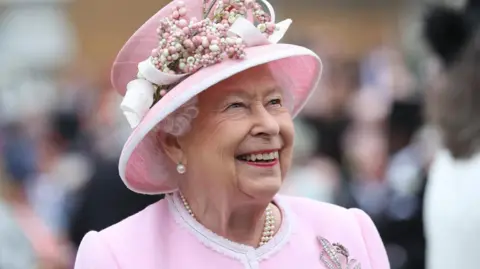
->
[75, 194, 390, 269]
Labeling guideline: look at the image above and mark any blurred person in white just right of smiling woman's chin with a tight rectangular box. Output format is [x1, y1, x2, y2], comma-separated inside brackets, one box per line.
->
[281, 119, 340, 203]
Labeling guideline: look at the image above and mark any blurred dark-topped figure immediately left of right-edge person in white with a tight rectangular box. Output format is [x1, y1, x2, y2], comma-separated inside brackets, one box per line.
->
[379, 101, 427, 269]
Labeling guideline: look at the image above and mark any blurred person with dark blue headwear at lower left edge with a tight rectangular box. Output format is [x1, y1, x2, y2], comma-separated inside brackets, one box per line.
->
[0, 122, 68, 269]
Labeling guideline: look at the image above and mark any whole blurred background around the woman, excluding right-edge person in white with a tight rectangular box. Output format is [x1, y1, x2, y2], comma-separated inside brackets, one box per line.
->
[0, 0, 463, 269]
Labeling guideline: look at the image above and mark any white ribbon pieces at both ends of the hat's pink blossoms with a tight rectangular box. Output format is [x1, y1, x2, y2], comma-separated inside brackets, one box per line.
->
[120, 0, 292, 128]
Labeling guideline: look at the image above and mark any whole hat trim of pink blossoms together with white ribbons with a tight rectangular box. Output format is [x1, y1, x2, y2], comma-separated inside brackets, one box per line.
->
[120, 0, 292, 128]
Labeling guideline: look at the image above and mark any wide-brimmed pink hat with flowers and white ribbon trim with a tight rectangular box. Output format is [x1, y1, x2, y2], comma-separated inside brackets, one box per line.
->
[112, 0, 322, 194]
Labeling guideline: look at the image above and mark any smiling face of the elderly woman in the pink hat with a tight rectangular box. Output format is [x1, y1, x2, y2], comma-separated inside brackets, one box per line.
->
[166, 63, 294, 198]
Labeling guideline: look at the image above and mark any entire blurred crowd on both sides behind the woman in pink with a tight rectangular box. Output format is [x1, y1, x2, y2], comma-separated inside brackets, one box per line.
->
[0, 0, 468, 269]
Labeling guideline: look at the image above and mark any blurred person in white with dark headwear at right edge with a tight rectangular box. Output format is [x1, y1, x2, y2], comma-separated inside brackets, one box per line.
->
[424, 0, 480, 269]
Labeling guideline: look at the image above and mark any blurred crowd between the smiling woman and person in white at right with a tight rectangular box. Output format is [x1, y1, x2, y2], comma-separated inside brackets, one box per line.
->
[284, 46, 438, 269]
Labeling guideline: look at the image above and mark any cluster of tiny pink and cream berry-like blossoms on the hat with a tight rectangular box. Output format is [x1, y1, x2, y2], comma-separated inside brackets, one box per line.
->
[151, 0, 276, 78]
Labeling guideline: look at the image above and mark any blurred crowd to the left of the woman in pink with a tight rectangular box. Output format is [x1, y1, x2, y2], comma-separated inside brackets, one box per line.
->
[0, 70, 163, 269]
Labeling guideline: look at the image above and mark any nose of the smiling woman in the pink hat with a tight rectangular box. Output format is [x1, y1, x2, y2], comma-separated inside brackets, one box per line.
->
[251, 105, 280, 138]
